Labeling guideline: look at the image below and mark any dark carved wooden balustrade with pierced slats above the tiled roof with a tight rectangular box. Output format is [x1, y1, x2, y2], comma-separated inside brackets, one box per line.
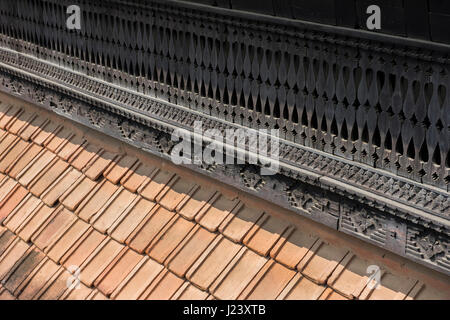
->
[0, 0, 450, 273]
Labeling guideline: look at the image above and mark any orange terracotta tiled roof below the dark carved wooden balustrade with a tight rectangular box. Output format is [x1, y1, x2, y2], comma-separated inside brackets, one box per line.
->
[0, 103, 450, 299]
